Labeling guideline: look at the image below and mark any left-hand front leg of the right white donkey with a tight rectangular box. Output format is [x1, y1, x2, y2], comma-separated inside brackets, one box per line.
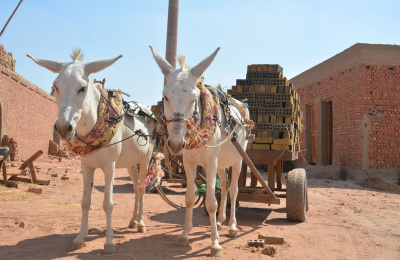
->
[177, 162, 197, 246]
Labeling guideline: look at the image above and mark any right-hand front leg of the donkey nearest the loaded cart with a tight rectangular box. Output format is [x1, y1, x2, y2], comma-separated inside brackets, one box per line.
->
[206, 159, 222, 257]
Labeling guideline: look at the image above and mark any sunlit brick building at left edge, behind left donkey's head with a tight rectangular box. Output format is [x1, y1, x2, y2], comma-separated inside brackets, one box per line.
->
[0, 45, 57, 159]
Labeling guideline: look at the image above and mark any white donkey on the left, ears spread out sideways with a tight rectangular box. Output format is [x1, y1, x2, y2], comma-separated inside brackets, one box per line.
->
[28, 50, 155, 253]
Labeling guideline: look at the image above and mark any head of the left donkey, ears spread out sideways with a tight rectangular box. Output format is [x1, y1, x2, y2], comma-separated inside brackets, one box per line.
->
[27, 49, 122, 140]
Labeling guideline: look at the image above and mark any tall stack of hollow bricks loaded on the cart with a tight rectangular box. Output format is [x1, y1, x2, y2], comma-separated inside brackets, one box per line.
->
[228, 64, 301, 151]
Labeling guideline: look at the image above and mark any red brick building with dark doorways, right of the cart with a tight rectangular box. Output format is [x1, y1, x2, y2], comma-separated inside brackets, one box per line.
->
[290, 44, 400, 182]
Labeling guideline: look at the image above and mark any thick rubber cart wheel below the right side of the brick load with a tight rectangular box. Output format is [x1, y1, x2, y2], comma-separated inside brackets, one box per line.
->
[286, 168, 308, 222]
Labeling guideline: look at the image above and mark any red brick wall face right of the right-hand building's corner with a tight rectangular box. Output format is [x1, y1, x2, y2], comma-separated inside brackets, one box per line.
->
[359, 63, 400, 169]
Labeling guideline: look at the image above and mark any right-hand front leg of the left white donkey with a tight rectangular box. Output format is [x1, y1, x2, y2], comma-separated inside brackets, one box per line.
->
[103, 162, 115, 254]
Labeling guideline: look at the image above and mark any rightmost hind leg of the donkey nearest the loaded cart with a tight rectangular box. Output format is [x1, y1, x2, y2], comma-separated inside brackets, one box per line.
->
[229, 160, 242, 237]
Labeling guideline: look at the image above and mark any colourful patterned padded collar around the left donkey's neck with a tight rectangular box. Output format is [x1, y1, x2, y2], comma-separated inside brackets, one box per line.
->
[67, 85, 122, 156]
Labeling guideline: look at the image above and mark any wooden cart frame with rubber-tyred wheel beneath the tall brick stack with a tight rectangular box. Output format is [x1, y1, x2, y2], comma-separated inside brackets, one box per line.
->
[231, 137, 308, 222]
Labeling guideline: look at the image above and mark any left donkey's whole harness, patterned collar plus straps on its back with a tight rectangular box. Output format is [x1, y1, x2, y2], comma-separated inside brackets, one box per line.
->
[67, 79, 154, 156]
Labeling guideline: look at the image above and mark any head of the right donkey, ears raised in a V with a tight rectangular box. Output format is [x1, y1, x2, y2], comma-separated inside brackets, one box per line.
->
[150, 45, 220, 155]
